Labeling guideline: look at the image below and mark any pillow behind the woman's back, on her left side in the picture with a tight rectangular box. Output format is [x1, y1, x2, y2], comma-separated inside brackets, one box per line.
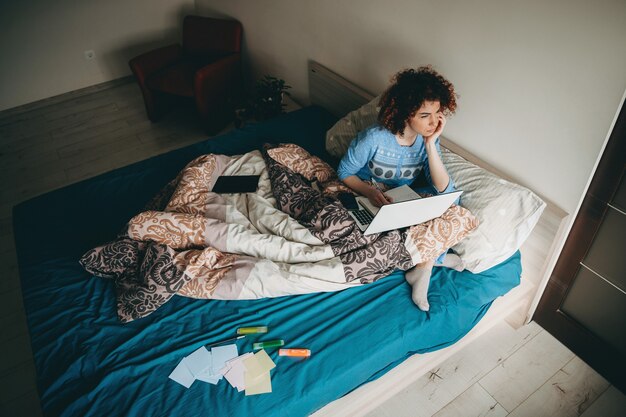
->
[326, 96, 380, 159]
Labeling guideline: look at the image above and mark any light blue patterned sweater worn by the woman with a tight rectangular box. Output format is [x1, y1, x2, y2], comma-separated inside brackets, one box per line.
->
[337, 124, 454, 193]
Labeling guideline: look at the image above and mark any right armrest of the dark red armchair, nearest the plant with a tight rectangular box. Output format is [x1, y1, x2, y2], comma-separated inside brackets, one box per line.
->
[194, 53, 242, 115]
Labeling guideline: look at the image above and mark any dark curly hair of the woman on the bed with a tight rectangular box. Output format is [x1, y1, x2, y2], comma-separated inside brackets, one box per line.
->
[378, 65, 458, 135]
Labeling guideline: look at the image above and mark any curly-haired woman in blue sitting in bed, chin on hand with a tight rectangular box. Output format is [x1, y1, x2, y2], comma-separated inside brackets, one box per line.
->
[337, 66, 462, 311]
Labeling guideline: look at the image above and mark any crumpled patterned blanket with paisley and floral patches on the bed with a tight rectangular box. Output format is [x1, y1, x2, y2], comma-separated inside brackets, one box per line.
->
[80, 144, 478, 322]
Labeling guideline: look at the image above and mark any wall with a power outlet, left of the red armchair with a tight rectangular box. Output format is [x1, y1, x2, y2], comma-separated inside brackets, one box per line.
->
[0, 0, 195, 110]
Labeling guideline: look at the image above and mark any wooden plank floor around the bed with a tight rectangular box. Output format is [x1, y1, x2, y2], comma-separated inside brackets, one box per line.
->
[0, 80, 626, 417]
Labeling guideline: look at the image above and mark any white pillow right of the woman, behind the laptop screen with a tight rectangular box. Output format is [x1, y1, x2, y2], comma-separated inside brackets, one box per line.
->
[441, 148, 546, 273]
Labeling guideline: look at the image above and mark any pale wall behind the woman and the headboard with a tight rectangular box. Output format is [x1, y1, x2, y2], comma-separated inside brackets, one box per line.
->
[196, 0, 626, 213]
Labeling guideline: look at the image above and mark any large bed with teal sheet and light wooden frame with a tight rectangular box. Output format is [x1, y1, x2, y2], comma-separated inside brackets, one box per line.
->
[14, 63, 565, 416]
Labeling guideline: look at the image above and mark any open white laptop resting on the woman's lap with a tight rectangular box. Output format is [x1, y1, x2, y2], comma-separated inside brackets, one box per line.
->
[348, 185, 463, 235]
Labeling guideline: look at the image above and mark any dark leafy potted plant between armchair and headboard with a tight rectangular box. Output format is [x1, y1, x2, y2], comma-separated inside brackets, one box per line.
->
[237, 75, 291, 125]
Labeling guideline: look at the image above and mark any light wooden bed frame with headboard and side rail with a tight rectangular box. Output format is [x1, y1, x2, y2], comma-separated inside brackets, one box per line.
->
[308, 61, 569, 417]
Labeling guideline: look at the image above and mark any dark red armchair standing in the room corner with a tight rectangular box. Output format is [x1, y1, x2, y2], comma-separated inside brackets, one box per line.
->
[129, 16, 243, 133]
